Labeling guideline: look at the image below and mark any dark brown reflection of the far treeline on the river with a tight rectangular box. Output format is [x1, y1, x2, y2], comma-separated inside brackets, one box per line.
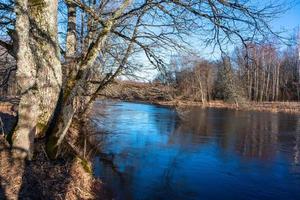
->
[170, 109, 300, 164]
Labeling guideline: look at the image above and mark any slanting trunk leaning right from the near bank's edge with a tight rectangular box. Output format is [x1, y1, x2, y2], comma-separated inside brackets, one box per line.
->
[47, 0, 131, 159]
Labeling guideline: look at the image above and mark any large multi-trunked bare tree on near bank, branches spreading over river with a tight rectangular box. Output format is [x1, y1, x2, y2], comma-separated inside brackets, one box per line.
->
[0, 0, 290, 158]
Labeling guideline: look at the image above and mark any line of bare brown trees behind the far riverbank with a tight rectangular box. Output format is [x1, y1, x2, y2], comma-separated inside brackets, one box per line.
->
[155, 43, 300, 104]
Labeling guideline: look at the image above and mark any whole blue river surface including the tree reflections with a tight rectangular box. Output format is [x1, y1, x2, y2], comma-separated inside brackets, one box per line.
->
[94, 102, 300, 200]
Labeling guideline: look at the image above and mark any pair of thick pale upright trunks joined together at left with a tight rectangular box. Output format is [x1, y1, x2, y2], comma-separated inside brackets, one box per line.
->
[12, 0, 62, 158]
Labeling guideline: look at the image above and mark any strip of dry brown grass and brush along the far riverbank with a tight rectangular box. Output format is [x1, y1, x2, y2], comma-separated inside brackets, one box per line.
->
[100, 81, 300, 114]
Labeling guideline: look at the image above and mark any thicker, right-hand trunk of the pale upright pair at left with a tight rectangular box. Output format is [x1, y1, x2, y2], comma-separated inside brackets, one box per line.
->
[29, 0, 62, 137]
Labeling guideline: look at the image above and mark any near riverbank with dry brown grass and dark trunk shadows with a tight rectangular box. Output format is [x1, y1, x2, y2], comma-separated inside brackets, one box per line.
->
[0, 102, 110, 200]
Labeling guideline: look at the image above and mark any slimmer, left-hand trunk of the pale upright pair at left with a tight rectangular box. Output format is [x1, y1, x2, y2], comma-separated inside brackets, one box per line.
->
[12, 0, 37, 156]
